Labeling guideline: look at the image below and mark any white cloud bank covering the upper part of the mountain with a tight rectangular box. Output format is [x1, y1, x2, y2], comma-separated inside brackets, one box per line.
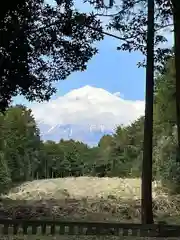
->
[31, 86, 144, 135]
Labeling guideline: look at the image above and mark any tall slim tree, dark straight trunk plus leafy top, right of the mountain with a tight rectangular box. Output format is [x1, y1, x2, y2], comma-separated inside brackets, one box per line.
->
[90, 0, 156, 223]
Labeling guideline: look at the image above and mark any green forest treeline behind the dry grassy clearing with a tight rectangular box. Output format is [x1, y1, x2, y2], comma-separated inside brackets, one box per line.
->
[0, 59, 180, 195]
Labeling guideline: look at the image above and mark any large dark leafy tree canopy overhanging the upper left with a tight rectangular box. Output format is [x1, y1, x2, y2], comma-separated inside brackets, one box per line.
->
[0, 0, 103, 110]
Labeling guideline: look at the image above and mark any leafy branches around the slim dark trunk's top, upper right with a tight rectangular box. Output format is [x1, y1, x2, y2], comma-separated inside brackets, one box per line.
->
[88, 0, 173, 70]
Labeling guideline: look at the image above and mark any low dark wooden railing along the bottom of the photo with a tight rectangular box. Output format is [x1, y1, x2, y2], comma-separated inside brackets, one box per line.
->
[0, 219, 180, 238]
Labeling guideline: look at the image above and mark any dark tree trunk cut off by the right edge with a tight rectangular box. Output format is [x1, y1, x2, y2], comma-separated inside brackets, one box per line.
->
[172, 0, 180, 161]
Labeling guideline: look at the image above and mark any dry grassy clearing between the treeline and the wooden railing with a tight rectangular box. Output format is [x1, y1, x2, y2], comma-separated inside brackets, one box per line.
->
[0, 177, 180, 240]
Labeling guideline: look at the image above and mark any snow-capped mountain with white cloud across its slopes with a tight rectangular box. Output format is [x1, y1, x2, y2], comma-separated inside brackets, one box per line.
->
[31, 85, 144, 146]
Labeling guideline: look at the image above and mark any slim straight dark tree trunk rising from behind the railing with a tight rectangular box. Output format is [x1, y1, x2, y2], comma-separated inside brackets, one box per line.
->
[141, 0, 154, 224]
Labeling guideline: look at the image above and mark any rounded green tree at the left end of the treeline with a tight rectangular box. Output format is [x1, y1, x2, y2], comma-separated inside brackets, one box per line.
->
[3, 106, 40, 181]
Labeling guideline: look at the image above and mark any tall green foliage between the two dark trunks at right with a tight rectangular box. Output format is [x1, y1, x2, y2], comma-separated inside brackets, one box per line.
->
[153, 59, 180, 193]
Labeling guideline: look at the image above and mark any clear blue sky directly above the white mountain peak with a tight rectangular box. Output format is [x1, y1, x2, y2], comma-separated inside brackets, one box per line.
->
[14, 0, 148, 105]
